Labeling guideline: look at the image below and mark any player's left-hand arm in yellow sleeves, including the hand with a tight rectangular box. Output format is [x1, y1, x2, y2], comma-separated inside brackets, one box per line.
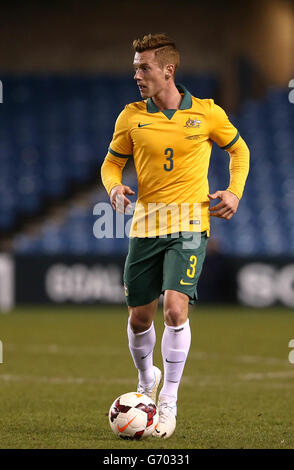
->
[101, 108, 135, 212]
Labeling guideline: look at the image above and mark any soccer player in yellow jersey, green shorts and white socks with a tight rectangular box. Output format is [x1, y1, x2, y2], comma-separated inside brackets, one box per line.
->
[101, 34, 249, 438]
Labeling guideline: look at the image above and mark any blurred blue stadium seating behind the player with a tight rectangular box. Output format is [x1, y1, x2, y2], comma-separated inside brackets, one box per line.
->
[0, 76, 294, 256]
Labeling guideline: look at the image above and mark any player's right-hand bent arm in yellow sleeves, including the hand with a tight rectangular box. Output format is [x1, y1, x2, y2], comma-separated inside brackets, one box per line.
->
[208, 103, 249, 220]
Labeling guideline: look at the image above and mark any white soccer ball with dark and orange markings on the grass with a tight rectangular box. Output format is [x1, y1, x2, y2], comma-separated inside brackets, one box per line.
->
[108, 392, 158, 439]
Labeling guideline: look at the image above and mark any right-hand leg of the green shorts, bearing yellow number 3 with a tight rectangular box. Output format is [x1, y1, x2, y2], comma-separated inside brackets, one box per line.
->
[163, 232, 208, 304]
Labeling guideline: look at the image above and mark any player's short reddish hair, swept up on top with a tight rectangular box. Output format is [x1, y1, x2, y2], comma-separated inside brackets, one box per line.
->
[133, 33, 180, 71]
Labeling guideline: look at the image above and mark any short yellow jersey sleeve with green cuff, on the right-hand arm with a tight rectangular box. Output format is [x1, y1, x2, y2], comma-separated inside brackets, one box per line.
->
[209, 100, 240, 150]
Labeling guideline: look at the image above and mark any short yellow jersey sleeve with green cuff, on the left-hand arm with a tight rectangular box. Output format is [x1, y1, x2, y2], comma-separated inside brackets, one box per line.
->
[108, 107, 133, 158]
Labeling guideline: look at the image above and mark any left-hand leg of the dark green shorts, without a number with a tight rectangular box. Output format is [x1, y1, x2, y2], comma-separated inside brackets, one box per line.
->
[124, 238, 164, 307]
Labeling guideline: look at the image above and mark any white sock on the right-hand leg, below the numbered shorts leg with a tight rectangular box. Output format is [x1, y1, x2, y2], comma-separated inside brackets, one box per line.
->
[159, 319, 191, 401]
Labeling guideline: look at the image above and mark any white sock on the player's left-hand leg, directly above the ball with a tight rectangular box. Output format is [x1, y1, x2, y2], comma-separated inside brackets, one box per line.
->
[127, 320, 156, 387]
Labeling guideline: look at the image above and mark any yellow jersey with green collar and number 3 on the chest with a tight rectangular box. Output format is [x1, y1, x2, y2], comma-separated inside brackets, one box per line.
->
[102, 85, 247, 237]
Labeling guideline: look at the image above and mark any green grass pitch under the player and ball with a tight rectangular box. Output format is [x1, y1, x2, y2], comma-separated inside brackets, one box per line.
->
[0, 306, 294, 449]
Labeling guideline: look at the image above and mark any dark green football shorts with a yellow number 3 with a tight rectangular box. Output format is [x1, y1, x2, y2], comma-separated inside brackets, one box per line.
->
[124, 232, 208, 307]
